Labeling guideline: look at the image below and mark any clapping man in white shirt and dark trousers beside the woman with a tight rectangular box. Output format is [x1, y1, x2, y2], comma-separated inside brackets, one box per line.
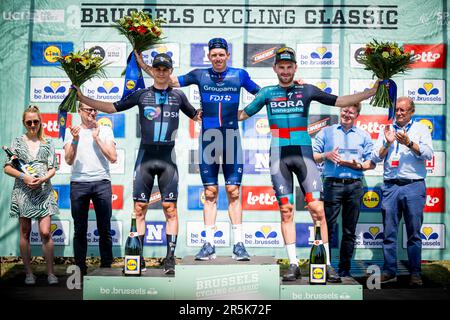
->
[64, 103, 117, 274]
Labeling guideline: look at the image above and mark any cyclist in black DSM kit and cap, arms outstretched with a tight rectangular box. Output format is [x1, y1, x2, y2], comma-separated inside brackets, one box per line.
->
[77, 53, 201, 274]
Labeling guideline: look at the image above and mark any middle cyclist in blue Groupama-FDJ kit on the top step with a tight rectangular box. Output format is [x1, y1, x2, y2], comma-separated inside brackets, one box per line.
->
[137, 38, 259, 261]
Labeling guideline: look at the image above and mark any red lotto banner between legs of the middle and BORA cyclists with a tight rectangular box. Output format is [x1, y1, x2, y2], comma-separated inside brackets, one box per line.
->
[242, 186, 280, 211]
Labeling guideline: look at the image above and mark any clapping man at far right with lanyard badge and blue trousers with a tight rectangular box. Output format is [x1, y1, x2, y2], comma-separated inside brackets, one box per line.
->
[372, 97, 433, 286]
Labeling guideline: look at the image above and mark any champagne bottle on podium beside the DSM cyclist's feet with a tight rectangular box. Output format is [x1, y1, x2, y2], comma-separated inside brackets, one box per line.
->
[124, 212, 142, 276]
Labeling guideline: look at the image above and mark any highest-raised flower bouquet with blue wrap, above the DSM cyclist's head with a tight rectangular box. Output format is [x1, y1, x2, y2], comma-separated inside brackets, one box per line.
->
[113, 11, 165, 99]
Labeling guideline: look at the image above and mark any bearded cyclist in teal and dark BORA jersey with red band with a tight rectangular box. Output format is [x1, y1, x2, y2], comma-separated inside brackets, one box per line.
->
[239, 47, 378, 282]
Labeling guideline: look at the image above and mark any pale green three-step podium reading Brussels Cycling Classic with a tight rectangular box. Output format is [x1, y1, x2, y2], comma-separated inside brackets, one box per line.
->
[83, 256, 363, 300]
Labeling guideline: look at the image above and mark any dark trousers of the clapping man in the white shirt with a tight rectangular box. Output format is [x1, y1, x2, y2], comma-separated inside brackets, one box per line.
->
[70, 180, 113, 272]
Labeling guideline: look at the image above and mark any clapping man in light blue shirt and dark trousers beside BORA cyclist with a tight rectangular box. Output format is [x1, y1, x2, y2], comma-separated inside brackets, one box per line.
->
[313, 103, 375, 277]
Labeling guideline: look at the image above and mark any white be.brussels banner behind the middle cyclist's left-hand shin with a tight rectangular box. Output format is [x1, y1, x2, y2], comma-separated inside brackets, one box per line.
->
[186, 221, 230, 247]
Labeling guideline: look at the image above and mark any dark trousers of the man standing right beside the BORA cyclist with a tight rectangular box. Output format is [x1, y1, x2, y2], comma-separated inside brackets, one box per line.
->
[323, 179, 363, 271]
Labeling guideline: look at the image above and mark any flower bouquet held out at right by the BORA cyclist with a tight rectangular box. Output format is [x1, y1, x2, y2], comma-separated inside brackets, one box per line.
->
[361, 39, 413, 119]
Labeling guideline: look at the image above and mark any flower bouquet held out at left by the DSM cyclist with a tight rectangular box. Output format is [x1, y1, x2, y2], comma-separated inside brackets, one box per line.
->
[58, 50, 106, 139]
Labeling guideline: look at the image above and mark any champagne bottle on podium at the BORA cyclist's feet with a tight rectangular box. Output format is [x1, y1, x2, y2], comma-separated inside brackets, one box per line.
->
[309, 221, 327, 284]
